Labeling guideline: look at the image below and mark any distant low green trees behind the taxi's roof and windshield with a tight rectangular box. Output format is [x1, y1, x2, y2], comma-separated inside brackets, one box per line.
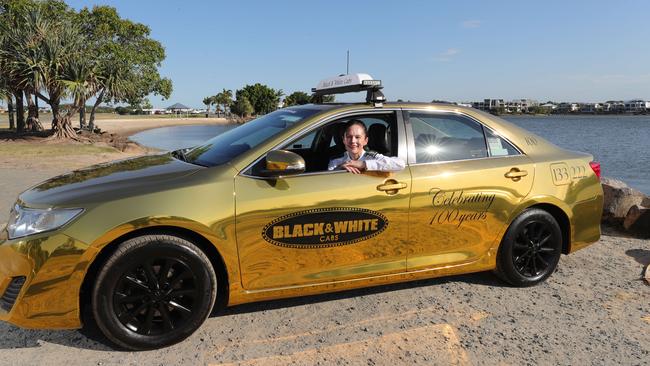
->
[203, 87, 334, 117]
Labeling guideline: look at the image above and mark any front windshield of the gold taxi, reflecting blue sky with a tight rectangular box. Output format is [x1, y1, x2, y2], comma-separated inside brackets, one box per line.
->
[184, 108, 319, 166]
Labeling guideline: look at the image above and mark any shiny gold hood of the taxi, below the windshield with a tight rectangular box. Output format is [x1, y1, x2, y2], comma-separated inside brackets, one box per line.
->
[18, 154, 205, 207]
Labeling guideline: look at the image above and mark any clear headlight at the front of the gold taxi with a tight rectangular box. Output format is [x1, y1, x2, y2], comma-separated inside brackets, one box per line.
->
[7, 205, 83, 239]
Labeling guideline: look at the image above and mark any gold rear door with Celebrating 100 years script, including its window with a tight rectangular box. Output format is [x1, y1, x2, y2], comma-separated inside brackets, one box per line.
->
[404, 110, 535, 271]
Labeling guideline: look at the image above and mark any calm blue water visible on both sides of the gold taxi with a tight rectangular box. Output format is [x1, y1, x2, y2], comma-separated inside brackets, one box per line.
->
[131, 116, 650, 194]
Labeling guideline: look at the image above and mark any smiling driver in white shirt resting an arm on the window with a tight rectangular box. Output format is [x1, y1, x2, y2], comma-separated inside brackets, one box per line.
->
[327, 119, 406, 174]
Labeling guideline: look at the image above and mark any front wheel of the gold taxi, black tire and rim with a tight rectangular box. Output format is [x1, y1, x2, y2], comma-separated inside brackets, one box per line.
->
[92, 235, 217, 350]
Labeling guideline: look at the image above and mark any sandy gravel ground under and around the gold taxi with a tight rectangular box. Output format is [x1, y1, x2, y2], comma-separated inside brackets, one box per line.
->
[0, 151, 650, 365]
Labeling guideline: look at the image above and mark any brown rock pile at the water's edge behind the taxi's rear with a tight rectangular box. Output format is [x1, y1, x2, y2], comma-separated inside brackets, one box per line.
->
[602, 178, 650, 239]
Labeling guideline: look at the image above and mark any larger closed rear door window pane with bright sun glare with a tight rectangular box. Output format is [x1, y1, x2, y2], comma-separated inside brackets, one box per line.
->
[409, 112, 488, 163]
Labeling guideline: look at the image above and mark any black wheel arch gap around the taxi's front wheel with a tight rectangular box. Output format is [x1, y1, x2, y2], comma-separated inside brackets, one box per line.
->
[79, 225, 230, 318]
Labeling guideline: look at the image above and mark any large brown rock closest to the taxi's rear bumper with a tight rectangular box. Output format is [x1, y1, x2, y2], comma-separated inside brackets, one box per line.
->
[601, 177, 647, 225]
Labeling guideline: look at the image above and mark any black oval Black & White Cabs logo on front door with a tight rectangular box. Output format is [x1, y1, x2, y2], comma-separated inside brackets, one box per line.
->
[262, 207, 388, 249]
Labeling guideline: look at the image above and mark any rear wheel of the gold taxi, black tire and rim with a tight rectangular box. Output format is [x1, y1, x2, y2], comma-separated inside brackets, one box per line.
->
[495, 208, 562, 287]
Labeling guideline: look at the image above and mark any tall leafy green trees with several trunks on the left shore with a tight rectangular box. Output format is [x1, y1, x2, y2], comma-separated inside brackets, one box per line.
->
[0, 0, 172, 138]
